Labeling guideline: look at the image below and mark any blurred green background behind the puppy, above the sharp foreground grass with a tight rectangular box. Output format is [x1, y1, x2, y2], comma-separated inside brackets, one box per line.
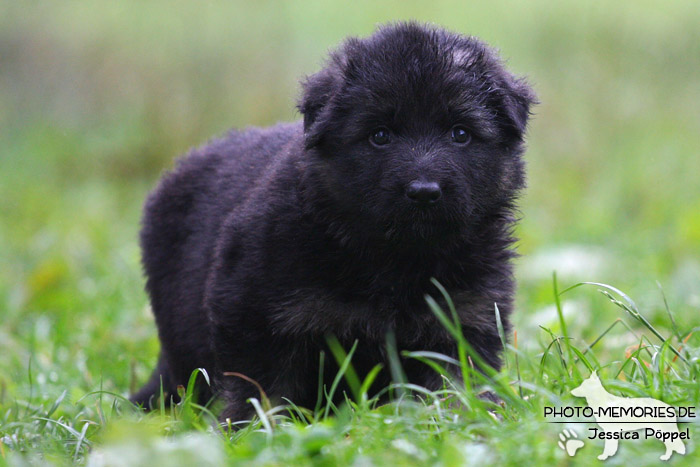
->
[0, 0, 700, 416]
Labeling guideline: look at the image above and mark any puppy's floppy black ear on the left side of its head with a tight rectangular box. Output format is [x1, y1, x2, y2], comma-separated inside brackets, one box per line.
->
[297, 65, 340, 149]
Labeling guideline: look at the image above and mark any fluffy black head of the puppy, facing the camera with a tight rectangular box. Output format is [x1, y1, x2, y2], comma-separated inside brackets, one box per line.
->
[299, 23, 535, 245]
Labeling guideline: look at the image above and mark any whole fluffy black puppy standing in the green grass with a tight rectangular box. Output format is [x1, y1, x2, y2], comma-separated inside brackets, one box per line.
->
[132, 23, 534, 420]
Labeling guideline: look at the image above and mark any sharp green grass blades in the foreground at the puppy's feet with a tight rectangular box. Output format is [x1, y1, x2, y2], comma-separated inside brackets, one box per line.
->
[0, 279, 700, 465]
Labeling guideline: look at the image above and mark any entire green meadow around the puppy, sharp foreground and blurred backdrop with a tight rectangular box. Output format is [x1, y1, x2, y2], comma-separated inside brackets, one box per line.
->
[0, 0, 700, 465]
